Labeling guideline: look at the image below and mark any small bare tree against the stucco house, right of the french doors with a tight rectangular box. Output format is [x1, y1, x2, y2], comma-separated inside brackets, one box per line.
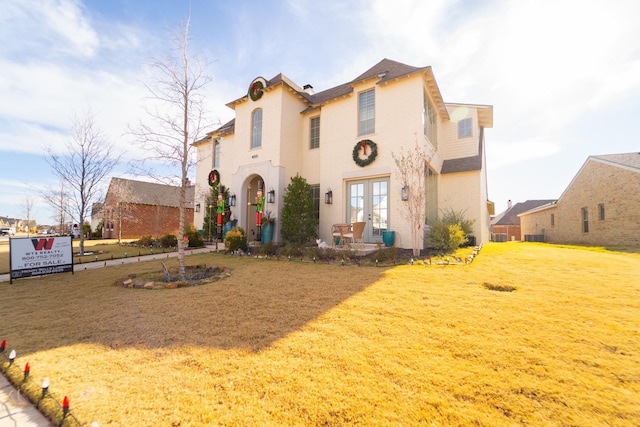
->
[391, 139, 433, 257]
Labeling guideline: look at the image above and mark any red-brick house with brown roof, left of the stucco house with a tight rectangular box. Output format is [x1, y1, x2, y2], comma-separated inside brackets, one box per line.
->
[102, 178, 194, 239]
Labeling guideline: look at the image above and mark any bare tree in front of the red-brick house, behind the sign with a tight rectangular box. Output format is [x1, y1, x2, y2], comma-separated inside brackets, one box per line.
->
[45, 111, 121, 255]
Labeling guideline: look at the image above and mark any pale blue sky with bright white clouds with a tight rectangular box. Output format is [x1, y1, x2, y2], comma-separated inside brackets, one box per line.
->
[0, 0, 640, 224]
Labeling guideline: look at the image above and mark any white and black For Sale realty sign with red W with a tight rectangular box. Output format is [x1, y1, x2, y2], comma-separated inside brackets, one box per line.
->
[9, 236, 73, 280]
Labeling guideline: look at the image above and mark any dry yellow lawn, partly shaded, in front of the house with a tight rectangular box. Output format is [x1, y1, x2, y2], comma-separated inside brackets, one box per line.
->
[0, 243, 640, 427]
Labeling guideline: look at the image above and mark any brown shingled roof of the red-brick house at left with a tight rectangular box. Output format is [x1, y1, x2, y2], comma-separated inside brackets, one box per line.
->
[107, 178, 195, 207]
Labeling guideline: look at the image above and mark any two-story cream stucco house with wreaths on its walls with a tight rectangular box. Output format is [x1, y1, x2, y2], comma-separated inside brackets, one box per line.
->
[194, 59, 493, 248]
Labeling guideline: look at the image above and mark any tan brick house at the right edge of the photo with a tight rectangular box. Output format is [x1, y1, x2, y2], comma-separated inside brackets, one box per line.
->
[520, 153, 640, 246]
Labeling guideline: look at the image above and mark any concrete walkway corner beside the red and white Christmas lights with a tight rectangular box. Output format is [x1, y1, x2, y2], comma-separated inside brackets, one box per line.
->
[0, 374, 53, 427]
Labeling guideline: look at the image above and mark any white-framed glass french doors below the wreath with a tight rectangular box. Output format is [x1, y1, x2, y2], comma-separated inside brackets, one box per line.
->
[347, 178, 389, 243]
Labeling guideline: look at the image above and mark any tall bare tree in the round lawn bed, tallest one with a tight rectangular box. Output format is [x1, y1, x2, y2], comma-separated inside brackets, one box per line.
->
[132, 20, 211, 279]
